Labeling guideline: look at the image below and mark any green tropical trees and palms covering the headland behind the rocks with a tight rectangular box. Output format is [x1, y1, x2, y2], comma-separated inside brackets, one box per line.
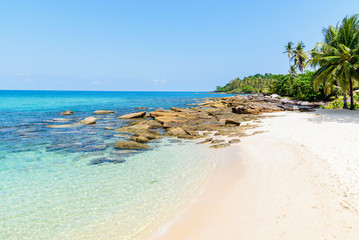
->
[216, 15, 359, 109]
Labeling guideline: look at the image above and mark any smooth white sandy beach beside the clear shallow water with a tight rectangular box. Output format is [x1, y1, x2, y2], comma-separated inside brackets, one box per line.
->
[150, 110, 359, 240]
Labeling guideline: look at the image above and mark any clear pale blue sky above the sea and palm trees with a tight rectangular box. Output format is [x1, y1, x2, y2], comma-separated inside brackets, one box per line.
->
[0, 0, 359, 91]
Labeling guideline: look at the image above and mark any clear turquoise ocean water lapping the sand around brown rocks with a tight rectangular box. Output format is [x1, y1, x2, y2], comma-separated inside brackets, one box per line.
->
[0, 91, 228, 240]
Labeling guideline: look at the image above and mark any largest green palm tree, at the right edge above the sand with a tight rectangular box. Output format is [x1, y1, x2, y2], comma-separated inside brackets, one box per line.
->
[310, 15, 359, 110]
